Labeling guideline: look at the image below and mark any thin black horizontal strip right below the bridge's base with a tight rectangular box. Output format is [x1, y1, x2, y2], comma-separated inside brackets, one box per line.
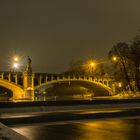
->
[0, 99, 140, 108]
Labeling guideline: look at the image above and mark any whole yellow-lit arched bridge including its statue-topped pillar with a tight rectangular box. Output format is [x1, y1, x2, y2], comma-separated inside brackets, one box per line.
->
[0, 58, 114, 99]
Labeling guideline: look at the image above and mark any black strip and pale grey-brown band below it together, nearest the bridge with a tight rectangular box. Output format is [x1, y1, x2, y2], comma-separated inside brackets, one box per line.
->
[0, 99, 140, 116]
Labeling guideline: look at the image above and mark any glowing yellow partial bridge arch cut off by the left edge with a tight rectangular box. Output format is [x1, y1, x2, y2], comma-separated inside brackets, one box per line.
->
[0, 79, 24, 99]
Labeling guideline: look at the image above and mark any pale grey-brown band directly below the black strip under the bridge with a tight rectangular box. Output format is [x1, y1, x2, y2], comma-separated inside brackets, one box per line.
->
[0, 103, 140, 114]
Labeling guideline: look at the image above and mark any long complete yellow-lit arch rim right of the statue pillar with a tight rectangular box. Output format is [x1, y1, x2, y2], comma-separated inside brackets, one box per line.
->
[35, 79, 112, 95]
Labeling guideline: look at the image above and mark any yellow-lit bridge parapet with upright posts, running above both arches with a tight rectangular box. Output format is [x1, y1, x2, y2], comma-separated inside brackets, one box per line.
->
[0, 71, 113, 89]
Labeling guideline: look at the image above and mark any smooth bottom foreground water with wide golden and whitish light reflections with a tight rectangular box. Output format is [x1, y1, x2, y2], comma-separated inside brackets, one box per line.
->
[12, 119, 140, 140]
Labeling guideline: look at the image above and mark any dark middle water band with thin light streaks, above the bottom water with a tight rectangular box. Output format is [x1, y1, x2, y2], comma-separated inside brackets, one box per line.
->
[0, 106, 140, 125]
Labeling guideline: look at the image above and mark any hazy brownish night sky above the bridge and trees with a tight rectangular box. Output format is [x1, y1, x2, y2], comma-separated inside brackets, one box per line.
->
[0, 0, 140, 72]
